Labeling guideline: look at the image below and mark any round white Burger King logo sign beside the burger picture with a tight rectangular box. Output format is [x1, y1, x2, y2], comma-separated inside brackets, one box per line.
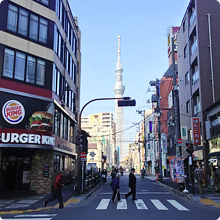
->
[2, 100, 25, 124]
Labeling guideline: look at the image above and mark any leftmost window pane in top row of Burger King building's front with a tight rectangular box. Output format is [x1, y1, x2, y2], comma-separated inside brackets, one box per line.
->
[7, 4, 18, 32]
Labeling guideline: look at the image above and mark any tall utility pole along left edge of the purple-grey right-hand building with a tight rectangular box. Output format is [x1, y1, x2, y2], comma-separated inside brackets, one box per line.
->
[171, 37, 182, 157]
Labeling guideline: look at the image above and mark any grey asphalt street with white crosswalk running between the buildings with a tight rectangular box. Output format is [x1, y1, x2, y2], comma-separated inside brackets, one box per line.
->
[2, 173, 220, 220]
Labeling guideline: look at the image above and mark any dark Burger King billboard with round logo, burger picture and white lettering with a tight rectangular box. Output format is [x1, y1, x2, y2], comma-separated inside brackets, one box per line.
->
[0, 92, 55, 146]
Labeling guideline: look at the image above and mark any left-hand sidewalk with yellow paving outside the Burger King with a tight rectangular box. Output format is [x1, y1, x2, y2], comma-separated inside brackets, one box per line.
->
[0, 183, 101, 216]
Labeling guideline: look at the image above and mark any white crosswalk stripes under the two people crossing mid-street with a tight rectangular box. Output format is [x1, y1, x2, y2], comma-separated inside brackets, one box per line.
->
[96, 199, 189, 211]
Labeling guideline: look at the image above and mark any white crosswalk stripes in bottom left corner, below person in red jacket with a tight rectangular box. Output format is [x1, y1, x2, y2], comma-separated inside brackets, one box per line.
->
[0, 214, 56, 220]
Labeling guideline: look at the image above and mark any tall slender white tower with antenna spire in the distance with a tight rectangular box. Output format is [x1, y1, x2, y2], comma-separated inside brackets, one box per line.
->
[114, 35, 127, 165]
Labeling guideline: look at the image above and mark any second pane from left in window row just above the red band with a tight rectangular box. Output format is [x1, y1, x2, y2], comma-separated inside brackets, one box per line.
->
[14, 52, 26, 81]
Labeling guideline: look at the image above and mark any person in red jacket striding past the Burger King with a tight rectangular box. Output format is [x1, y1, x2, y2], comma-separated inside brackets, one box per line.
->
[43, 171, 64, 209]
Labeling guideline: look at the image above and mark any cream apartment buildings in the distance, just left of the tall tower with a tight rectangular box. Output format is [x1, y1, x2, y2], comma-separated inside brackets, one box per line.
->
[81, 112, 116, 169]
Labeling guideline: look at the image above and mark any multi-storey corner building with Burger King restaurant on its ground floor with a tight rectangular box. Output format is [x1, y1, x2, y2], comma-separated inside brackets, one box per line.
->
[0, 0, 81, 194]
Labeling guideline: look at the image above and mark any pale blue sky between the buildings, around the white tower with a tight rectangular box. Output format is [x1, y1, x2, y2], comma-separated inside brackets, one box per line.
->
[69, 0, 189, 142]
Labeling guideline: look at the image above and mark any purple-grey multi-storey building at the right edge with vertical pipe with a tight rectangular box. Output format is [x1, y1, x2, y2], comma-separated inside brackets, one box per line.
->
[177, 0, 220, 187]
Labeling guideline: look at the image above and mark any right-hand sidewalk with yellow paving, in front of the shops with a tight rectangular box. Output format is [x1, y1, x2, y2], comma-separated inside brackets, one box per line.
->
[147, 175, 220, 208]
